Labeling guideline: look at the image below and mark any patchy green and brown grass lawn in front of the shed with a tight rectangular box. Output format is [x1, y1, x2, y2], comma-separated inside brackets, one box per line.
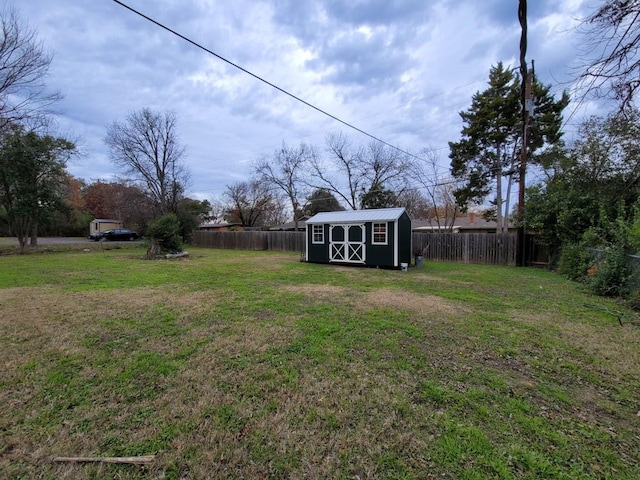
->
[0, 249, 640, 480]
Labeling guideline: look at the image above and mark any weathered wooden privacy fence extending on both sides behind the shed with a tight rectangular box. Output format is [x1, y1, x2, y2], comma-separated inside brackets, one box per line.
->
[192, 231, 516, 265]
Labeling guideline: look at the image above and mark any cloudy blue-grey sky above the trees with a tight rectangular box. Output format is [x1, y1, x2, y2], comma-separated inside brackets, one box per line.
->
[15, 0, 600, 199]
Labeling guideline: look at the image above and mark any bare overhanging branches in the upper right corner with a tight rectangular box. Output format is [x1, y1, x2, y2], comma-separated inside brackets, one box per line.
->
[580, 0, 640, 109]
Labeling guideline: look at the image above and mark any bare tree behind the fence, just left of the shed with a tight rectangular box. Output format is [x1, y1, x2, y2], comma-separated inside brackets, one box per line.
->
[254, 142, 317, 231]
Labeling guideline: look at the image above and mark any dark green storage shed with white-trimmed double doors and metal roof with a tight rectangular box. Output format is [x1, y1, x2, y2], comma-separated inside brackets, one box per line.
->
[306, 208, 411, 268]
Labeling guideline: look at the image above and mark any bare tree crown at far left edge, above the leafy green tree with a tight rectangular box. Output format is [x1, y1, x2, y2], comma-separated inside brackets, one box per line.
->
[0, 8, 62, 132]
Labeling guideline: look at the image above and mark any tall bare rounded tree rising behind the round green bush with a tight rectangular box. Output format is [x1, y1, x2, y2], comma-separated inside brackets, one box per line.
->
[105, 108, 189, 215]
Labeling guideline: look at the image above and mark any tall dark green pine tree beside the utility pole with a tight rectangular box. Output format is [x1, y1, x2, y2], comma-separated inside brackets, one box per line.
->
[449, 62, 569, 231]
